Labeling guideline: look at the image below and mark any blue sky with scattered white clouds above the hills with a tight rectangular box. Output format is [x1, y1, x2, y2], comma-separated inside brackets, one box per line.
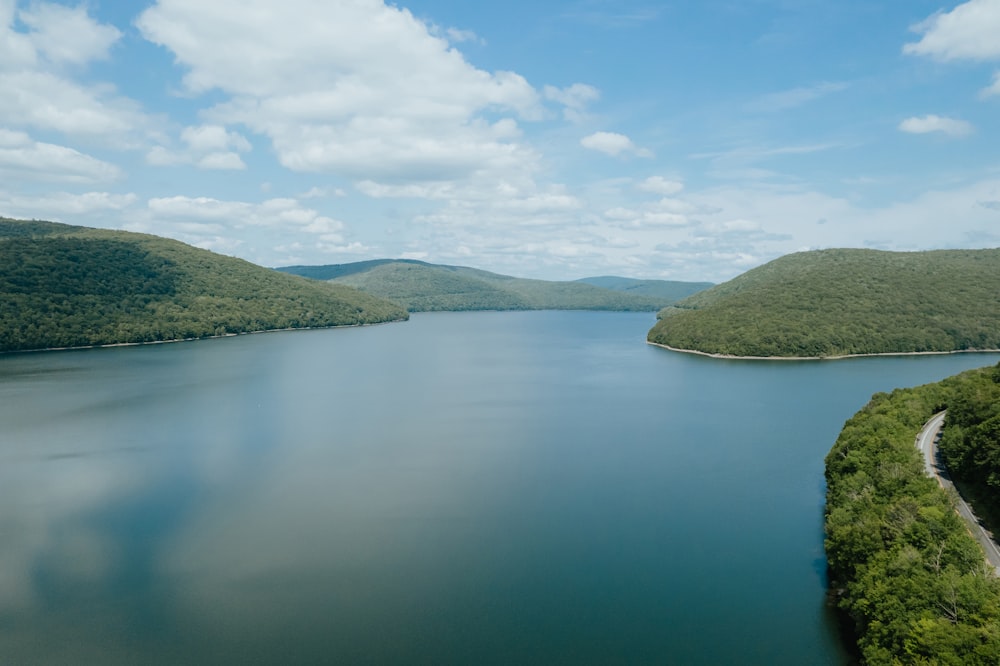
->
[0, 0, 1000, 282]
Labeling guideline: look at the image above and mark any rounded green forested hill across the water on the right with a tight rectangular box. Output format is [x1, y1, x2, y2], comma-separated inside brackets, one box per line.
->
[648, 249, 1000, 357]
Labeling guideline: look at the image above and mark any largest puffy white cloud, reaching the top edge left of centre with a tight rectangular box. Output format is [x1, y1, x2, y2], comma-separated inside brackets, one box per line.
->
[136, 0, 543, 183]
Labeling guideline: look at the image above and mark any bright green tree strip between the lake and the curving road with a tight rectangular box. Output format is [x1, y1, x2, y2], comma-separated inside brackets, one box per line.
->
[826, 368, 1000, 666]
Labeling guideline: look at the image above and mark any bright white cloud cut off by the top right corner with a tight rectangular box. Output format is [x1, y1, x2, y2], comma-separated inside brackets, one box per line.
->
[903, 0, 1000, 61]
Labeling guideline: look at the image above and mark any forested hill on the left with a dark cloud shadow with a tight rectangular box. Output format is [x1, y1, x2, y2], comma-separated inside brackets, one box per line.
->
[0, 218, 407, 351]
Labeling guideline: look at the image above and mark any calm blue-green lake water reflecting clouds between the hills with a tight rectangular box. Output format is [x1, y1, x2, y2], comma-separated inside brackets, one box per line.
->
[0, 312, 1000, 665]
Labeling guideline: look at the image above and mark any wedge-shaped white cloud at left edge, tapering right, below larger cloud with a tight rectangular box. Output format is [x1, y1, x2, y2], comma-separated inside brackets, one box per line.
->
[0, 129, 122, 183]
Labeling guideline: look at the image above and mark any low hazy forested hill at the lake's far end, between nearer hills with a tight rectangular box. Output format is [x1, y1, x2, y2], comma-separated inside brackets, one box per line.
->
[278, 259, 704, 312]
